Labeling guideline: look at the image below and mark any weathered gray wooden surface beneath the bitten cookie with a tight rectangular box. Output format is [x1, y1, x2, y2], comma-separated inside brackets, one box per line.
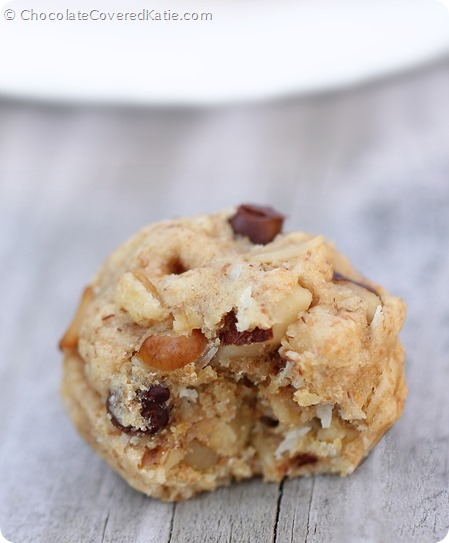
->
[0, 62, 449, 543]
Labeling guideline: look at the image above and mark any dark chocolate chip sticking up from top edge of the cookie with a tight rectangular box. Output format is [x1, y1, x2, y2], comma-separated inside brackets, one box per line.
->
[229, 204, 285, 245]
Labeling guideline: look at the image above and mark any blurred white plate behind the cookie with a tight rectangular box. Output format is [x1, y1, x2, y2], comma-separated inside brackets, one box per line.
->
[0, 0, 449, 104]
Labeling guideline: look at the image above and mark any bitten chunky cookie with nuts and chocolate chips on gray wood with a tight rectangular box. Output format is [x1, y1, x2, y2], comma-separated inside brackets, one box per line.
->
[60, 205, 406, 501]
